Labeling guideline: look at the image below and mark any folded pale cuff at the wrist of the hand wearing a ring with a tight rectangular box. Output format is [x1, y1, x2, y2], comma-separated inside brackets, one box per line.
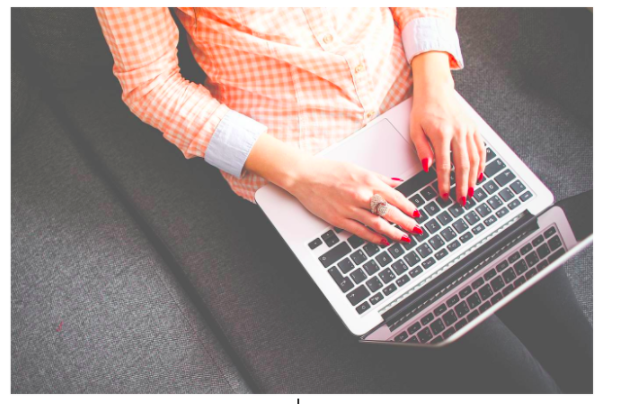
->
[204, 110, 268, 177]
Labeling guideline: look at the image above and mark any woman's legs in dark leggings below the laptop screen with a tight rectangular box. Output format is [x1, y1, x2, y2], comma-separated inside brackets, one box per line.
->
[390, 269, 593, 393]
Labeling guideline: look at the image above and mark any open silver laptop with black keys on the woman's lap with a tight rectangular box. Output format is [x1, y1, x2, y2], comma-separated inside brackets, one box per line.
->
[255, 95, 593, 347]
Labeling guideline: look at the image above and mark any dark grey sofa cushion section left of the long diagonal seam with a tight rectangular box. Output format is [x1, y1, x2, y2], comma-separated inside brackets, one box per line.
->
[11, 65, 249, 393]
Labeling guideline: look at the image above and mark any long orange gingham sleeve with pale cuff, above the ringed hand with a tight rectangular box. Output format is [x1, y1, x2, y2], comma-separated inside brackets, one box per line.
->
[96, 7, 267, 177]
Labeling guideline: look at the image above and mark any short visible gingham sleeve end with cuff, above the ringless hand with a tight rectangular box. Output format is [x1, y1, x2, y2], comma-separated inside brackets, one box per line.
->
[390, 7, 464, 70]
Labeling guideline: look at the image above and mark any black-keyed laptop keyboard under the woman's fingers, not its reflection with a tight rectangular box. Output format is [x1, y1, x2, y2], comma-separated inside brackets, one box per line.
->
[308, 147, 533, 314]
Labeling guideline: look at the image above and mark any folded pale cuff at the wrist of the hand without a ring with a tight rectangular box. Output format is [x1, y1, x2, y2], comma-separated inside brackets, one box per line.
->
[401, 17, 463, 69]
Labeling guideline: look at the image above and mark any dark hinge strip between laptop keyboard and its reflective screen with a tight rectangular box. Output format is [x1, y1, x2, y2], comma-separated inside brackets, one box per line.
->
[382, 211, 538, 330]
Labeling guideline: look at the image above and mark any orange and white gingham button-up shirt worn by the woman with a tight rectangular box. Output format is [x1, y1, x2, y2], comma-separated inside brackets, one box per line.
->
[96, 7, 463, 202]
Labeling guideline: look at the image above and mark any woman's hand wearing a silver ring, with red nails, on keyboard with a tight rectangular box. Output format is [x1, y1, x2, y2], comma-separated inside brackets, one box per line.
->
[283, 157, 422, 245]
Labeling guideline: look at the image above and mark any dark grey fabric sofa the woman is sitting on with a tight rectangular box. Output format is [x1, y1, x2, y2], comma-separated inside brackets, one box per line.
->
[11, 8, 593, 394]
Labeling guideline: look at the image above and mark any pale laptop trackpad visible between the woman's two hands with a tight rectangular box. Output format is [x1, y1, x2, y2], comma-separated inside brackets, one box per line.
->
[319, 118, 422, 177]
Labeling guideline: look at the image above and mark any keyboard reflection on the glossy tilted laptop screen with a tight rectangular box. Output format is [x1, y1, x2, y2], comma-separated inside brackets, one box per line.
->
[391, 226, 565, 343]
